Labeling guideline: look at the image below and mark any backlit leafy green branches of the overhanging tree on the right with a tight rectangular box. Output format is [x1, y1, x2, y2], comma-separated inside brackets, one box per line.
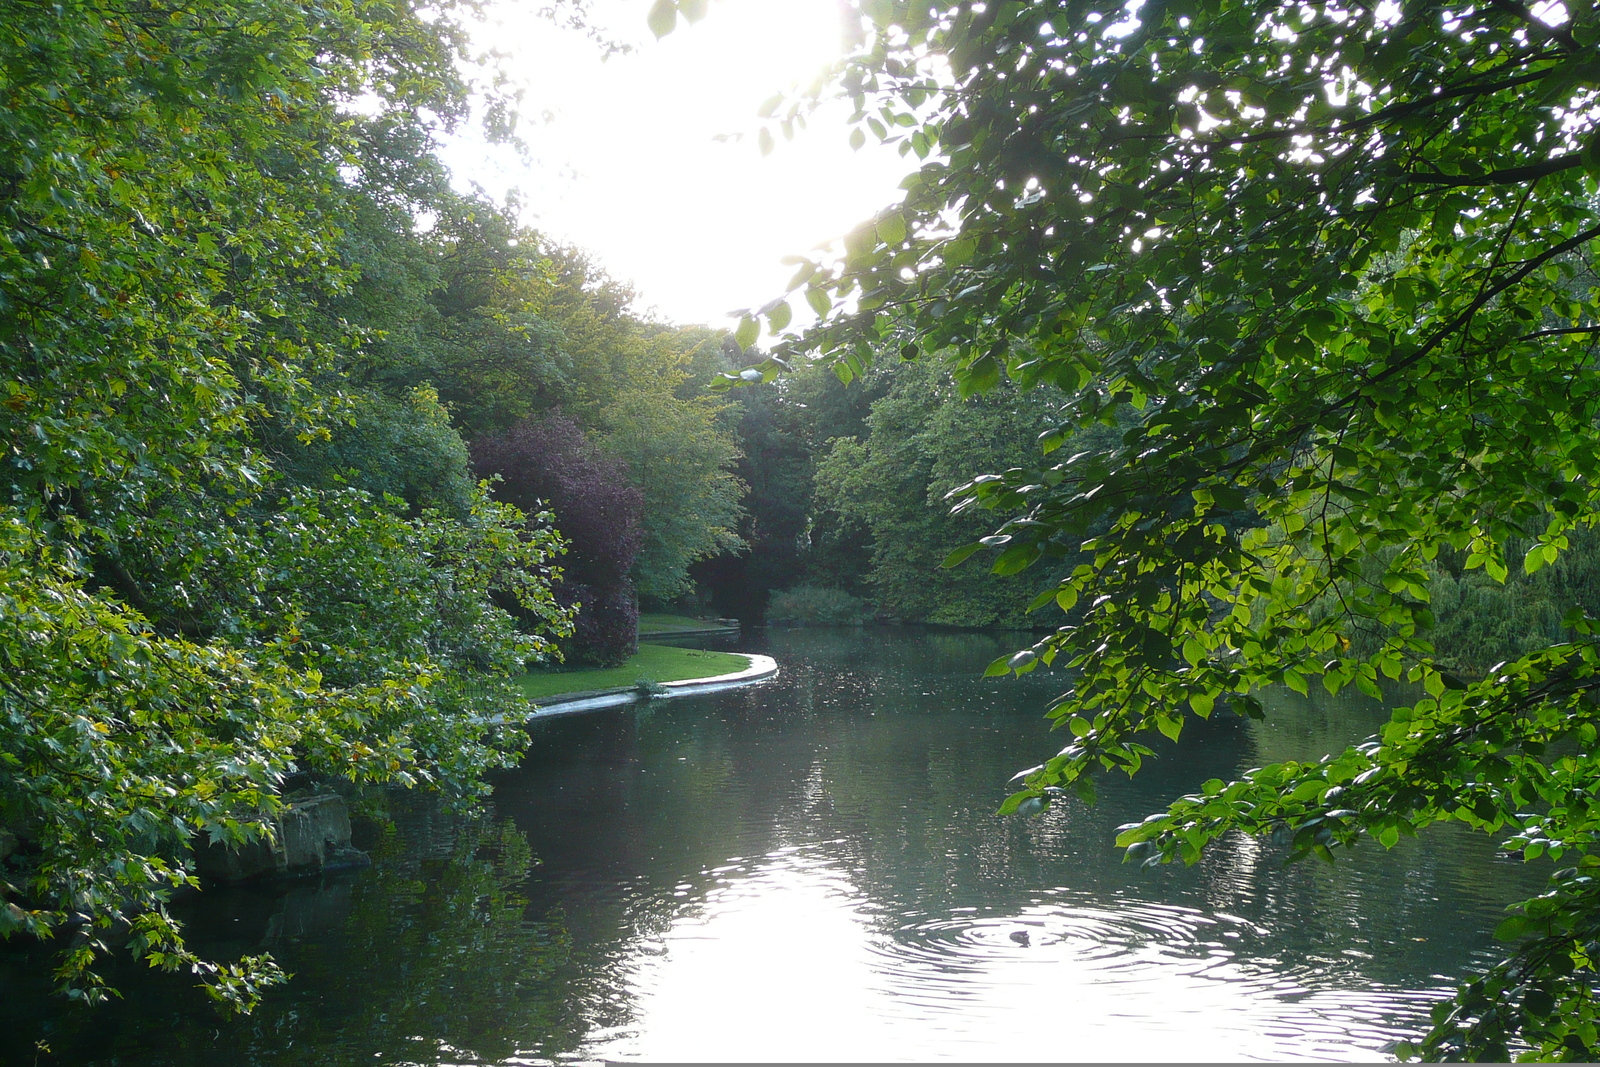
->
[672, 0, 1600, 1059]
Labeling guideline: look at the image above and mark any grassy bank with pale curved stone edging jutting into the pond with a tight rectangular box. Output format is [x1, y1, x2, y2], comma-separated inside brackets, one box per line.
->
[517, 645, 778, 710]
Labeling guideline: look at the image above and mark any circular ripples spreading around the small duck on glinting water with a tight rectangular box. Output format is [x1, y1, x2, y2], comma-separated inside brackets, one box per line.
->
[851, 891, 1445, 1059]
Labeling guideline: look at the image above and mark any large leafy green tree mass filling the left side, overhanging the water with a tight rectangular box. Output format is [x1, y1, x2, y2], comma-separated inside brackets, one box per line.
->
[0, 0, 568, 1008]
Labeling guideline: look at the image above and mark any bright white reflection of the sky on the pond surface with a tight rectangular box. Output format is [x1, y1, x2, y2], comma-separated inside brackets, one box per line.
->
[586, 843, 1437, 1062]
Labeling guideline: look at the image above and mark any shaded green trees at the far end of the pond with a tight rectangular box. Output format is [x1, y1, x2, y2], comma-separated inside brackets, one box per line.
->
[710, 360, 1110, 629]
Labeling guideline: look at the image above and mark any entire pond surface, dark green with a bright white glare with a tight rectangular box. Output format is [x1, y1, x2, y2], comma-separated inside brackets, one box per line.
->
[0, 630, 1547, 1064]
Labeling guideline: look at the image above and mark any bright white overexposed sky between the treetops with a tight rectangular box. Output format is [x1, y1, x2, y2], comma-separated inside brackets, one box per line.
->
[445, 0, 917, 325]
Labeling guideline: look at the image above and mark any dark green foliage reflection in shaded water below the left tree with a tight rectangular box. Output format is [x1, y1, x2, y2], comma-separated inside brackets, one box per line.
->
[0, 797, 568, 1067]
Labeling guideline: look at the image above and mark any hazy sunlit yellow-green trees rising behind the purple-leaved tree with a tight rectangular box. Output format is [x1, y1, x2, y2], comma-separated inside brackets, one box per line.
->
[387, 223, 744, 607]
